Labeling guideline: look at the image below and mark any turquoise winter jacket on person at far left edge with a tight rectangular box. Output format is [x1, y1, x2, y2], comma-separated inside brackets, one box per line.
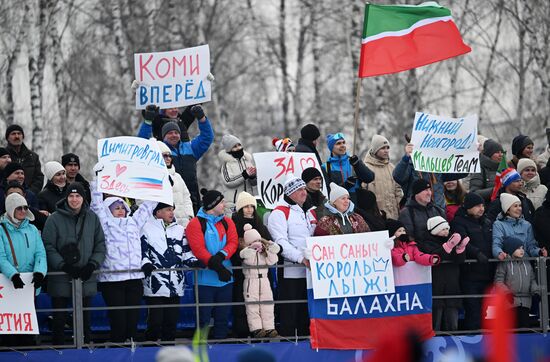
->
[0, 215, 48, 295]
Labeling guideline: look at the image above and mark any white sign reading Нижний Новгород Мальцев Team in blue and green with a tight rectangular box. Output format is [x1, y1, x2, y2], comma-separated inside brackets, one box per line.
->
[411, 112, 480, 173]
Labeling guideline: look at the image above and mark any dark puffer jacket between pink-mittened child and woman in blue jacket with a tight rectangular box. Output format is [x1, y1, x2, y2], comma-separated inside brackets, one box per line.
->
[451, 207, 496, 282]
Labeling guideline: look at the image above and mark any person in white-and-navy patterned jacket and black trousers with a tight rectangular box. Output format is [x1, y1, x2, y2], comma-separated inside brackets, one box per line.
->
[141, 203, 200, 341]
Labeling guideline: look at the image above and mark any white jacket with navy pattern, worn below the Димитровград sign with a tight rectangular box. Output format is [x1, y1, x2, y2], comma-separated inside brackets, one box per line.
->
[141, 217, 197, 297]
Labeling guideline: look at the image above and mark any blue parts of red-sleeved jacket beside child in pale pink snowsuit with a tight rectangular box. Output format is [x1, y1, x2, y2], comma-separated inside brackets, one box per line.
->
[197, 207, 233, 287]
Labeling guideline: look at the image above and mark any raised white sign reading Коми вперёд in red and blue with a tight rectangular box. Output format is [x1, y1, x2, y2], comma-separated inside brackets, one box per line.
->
[134, 45, 211, 109]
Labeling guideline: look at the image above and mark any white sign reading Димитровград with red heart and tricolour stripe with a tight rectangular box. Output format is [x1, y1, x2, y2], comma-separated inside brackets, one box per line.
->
[97, 137, 173, 205]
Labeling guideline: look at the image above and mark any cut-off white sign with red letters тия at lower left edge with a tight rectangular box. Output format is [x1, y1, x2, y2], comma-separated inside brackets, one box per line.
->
[0, 273, 40, 334]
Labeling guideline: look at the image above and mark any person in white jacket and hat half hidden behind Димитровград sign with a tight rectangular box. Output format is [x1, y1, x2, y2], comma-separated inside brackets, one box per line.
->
[157, 141, 195, 228]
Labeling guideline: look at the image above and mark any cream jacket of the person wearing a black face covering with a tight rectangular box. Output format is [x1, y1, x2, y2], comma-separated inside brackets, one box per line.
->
[218, 150, 256, 215]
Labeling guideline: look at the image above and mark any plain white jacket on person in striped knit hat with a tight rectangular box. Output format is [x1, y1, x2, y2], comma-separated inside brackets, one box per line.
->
[267, 200, 317, 279]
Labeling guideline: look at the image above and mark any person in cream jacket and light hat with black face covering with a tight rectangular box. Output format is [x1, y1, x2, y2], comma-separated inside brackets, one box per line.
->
[218, 135, 256, 217]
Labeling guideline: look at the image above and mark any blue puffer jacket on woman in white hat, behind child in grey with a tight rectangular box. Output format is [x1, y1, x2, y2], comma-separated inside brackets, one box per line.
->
[493, 213, 540, 258]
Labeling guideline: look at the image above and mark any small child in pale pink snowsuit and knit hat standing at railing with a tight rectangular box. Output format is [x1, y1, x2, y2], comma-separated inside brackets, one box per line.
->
[240, 224, 280, 338]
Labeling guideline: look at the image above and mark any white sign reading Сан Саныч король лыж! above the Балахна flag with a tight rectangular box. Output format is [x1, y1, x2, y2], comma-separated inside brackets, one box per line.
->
[307, 231, 395, 299]
